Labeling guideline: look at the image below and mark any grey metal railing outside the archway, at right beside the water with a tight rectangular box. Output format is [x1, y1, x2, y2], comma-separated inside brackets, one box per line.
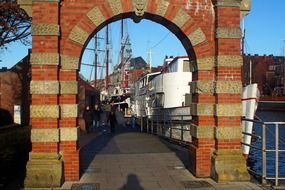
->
[242, 118, 285, 186]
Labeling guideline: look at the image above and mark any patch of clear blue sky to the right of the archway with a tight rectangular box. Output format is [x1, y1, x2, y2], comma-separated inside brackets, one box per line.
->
[244, 0, 285, 56]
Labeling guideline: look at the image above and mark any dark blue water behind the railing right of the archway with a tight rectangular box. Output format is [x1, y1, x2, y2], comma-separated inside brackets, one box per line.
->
[249, 111, 285, 177]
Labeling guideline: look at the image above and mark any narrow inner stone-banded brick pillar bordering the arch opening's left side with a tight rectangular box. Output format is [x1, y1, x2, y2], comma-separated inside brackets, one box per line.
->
[59, 55, 80, 181]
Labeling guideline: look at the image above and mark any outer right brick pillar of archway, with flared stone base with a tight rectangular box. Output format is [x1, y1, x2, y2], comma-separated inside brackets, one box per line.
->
[211, 0, 249, 182]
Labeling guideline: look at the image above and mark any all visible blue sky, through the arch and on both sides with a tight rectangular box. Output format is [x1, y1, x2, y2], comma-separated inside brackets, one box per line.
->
[0, 0, 285, 78]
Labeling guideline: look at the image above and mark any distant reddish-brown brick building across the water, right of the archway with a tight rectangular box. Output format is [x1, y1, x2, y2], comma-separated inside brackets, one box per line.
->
[242, 54, 285, 96]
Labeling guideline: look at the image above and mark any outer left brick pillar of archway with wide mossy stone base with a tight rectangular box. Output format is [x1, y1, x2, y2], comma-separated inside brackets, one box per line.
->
[25, 0, 63, 188]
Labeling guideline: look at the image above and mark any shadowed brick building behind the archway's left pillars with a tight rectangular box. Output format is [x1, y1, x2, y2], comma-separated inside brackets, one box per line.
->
[0, 53, 100, 131]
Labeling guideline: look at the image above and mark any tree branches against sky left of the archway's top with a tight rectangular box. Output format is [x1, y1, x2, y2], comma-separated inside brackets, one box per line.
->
[0, 0, 31, 49]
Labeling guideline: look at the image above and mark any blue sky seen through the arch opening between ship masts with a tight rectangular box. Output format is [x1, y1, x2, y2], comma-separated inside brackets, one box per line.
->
[80, 19, 186, 79]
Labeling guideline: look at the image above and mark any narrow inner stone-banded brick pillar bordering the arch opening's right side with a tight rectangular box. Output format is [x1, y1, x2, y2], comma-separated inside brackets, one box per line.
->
[189, 59, 215, 177]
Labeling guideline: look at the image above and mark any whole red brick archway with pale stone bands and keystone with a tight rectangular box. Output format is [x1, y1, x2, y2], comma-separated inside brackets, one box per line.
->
[25, 0, 248, 187]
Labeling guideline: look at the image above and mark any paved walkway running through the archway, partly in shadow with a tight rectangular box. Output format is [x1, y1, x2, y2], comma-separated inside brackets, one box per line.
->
[62, 110, 260, 190]
